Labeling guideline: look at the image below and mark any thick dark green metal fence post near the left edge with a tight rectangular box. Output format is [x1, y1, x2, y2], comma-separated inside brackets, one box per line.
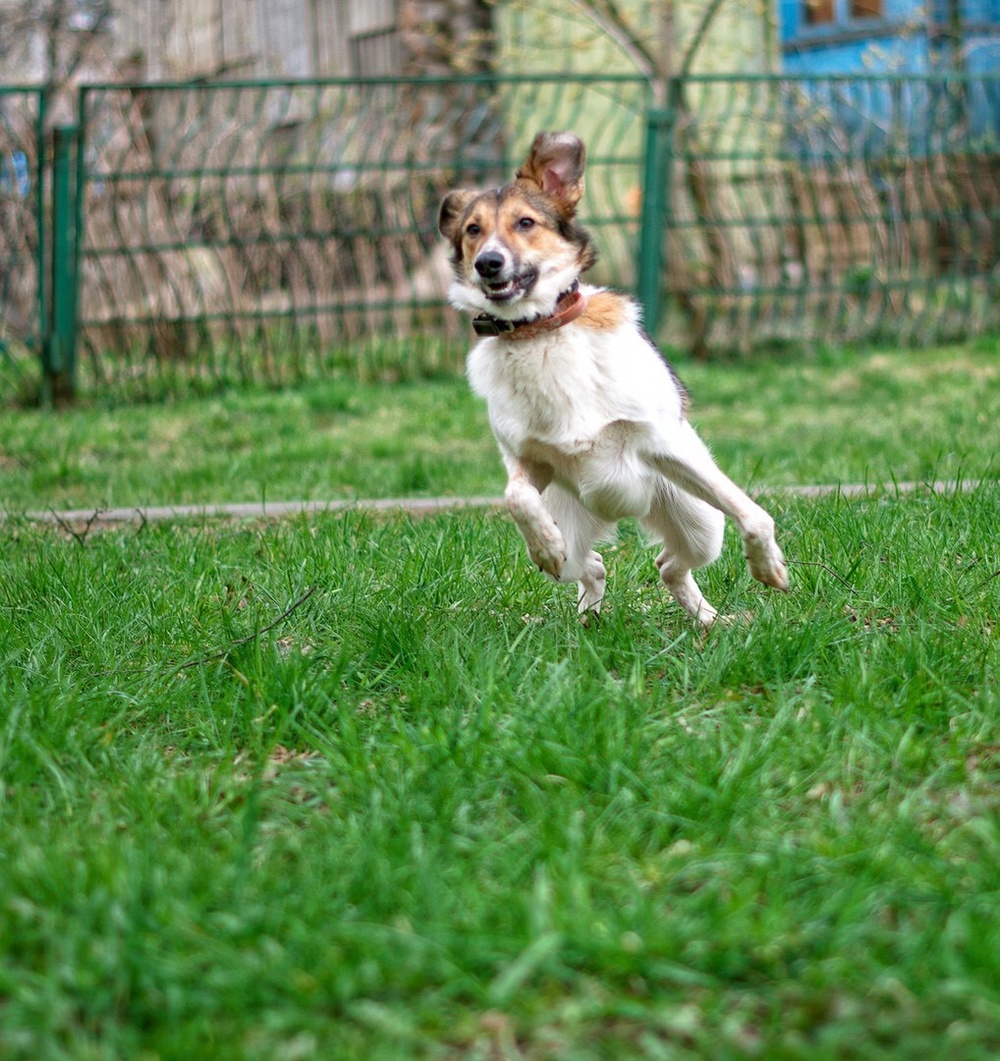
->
[42, 125, 77, 404]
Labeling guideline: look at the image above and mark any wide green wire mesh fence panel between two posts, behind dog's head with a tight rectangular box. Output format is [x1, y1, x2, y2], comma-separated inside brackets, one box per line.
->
[70, 79, 647, 398]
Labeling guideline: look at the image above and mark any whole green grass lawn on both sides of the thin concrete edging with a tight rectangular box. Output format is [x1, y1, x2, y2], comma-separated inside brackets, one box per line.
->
[0, 337, 1000, 1061]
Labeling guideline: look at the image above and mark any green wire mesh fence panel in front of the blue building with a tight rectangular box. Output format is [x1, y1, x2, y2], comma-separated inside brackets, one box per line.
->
[661, 76, 1000, 353]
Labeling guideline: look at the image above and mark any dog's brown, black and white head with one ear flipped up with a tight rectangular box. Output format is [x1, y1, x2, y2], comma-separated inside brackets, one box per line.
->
[438, 133, 597, 320]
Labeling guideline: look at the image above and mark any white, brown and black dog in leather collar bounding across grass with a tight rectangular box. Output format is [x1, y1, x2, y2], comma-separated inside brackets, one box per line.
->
[438, 133, 788, 627]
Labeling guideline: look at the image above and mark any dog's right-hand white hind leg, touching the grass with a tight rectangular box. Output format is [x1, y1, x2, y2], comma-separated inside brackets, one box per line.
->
[643, 483, 724, 626]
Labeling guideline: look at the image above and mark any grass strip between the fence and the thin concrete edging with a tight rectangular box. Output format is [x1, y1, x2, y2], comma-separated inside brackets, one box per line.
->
[0, 341, 1000, 511]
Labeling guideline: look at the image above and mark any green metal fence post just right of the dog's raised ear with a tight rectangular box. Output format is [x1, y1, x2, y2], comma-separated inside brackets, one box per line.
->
[636, 108, 673, 335]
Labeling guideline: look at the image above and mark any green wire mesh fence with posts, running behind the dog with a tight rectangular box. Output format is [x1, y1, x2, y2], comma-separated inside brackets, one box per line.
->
[0, 75, 1000, 397]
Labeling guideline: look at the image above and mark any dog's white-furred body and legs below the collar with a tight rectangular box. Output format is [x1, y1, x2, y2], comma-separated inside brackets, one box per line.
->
[462, 280, 788, 626]
